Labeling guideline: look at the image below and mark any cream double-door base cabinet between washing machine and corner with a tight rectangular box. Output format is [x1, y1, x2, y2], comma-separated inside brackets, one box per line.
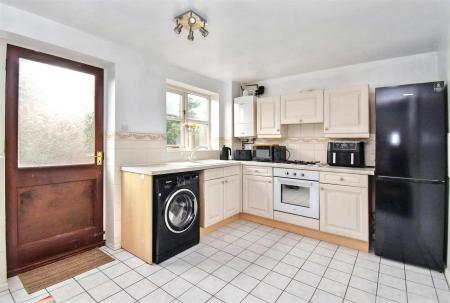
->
[200, 165, 242, 227]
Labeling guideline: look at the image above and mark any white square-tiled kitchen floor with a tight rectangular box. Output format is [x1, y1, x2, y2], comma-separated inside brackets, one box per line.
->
[0, 221, 450, 303]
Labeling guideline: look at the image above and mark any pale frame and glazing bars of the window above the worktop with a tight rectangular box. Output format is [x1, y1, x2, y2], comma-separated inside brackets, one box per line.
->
[166, 85, 211, 150]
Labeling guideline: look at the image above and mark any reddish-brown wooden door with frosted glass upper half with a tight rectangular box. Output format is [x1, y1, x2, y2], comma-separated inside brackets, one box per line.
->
[6, 45, 103, 276]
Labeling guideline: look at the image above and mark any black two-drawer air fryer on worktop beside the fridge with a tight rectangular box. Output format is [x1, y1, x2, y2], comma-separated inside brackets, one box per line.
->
[327, 141, 365, 167]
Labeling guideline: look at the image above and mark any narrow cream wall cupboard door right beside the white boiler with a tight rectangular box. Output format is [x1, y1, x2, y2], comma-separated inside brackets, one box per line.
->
[256, 97, 281, 136]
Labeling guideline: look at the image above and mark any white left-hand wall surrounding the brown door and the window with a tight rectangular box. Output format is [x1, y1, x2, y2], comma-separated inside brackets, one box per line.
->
[0, 4, 229, 289]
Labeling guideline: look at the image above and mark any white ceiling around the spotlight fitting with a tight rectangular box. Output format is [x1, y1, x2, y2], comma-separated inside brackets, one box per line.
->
[0, 0, 450, 81]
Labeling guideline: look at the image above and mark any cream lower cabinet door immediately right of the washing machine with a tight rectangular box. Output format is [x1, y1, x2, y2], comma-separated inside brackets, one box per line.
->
[201, 178, 224, 227]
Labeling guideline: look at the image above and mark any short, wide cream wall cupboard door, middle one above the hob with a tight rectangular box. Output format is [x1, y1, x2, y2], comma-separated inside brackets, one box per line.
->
[281, 90, 323, 124]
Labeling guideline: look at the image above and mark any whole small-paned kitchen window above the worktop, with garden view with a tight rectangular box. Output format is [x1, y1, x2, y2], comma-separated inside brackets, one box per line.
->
[166, 87, 215, 150]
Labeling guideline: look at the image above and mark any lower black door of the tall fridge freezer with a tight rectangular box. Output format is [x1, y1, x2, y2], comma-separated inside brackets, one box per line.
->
[375, 177, 447, 270]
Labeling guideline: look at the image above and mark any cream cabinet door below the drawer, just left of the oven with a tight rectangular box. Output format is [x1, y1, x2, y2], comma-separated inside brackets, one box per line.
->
[242, 175, 273, 219]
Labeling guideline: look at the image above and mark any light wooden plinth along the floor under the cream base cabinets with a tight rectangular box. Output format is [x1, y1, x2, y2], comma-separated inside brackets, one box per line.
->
[200, 213, 369, 252]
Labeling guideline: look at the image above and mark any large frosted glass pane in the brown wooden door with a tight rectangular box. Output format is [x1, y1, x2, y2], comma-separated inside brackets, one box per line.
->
[18, 58, 95, 167]
